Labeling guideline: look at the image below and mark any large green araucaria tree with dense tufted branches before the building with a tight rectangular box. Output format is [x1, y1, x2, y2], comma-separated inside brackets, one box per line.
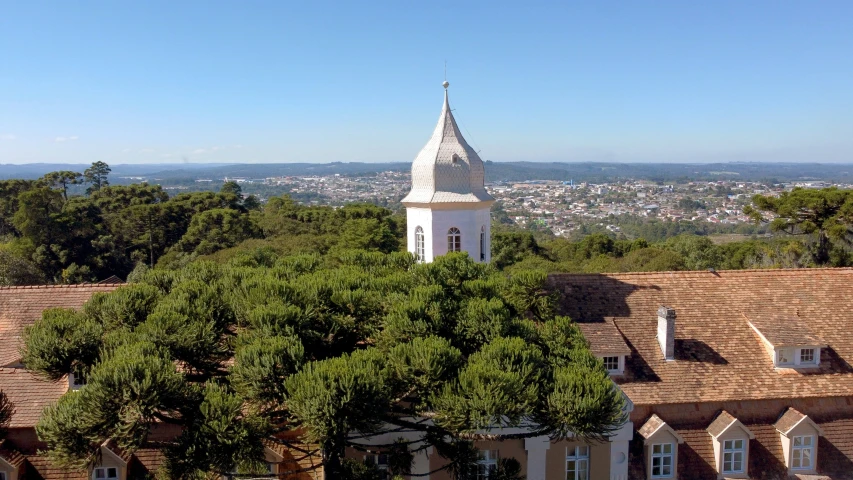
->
[24, 251, 624, 479]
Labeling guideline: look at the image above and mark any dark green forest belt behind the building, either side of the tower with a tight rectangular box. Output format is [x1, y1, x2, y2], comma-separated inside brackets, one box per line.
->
[0, 162, 853, 285]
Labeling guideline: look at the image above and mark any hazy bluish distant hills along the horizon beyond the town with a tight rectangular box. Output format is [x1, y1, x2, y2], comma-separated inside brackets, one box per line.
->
[0, 162, 853, 184]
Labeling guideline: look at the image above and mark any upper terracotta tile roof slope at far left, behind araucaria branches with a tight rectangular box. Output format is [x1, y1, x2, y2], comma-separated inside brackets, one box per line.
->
[0, 284, 121, 367]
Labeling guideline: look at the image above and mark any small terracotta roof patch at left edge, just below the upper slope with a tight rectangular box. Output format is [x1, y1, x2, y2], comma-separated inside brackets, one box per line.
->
[0, 368, 68, 428]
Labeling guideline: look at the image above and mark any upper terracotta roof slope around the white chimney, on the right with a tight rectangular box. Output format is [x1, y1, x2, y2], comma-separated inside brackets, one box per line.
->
[549, 268, 853, 405]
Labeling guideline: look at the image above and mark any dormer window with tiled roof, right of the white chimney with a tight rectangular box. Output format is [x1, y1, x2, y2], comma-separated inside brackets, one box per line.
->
[748, 316, 826, 368]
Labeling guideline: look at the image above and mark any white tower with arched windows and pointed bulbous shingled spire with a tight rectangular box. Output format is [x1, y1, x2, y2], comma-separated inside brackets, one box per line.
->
[402, 82, 495, 262]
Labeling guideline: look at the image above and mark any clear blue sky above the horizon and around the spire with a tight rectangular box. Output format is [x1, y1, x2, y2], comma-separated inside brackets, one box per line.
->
[0, 0, 853, 164]
